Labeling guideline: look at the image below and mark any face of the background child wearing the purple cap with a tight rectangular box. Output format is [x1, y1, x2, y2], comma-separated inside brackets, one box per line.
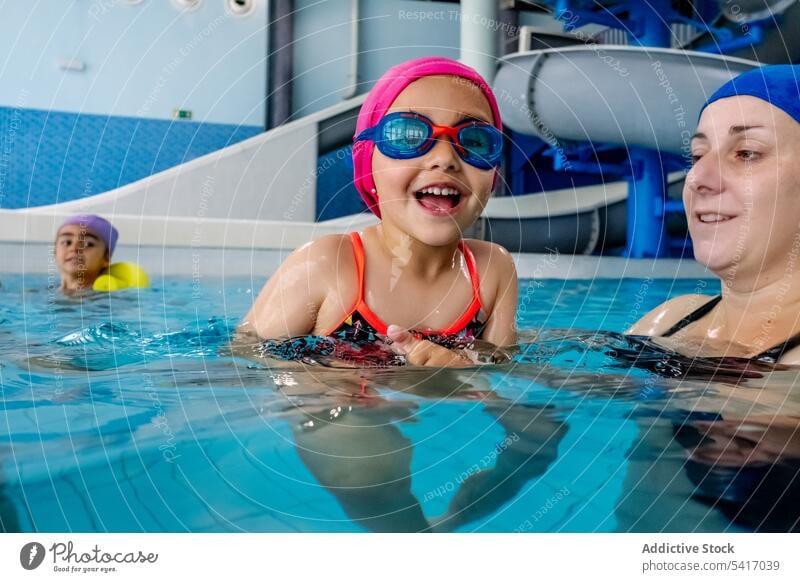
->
[56, 224, 108, 287]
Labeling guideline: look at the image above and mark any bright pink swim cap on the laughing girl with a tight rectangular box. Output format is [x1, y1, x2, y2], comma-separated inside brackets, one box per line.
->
[353, 57, 503, 218]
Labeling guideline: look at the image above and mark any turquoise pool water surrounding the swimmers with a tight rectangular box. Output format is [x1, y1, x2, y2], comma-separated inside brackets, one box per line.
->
[0, 276, 800, 532]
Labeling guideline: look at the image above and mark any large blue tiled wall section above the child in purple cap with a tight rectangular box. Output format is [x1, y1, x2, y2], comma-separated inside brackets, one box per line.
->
[0, 107, 263, 208]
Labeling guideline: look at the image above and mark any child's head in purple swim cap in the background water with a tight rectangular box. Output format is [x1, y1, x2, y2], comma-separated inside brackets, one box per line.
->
[55, 214, 119, 293]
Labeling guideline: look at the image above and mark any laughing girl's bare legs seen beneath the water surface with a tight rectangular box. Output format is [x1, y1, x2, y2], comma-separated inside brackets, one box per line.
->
[295, 392, 565, 532]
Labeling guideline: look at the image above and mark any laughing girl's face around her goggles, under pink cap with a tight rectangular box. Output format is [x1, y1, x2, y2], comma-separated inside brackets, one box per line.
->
[372, 75, 494, 246]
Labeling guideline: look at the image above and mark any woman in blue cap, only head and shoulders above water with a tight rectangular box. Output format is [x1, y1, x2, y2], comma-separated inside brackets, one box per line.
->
[628, 65, 800, 365]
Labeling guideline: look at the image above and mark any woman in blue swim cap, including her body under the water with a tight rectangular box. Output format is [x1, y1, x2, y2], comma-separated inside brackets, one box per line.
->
[617, 65, 800, 532]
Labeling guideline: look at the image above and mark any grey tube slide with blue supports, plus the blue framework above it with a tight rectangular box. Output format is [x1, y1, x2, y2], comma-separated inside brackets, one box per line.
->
[484, 0, 800, 257]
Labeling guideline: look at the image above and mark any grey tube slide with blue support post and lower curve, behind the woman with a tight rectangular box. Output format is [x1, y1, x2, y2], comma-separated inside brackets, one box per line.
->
[494, 45, 757, 257]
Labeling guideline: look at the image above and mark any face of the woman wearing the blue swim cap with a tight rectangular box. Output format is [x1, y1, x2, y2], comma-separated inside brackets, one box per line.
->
[683, 96, 800, 284]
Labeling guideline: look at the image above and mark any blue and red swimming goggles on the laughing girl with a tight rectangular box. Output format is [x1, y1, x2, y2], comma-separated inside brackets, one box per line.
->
[356, 111, 503, 170]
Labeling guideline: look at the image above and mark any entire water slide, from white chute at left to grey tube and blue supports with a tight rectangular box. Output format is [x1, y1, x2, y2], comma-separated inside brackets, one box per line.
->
[0, 0, 800, 257]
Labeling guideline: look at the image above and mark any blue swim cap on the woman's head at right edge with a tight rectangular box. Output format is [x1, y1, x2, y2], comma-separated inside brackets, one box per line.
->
[700, 65, 800, 123]
